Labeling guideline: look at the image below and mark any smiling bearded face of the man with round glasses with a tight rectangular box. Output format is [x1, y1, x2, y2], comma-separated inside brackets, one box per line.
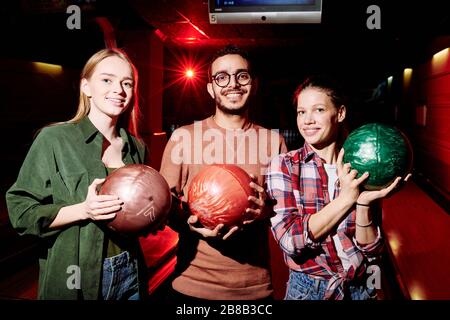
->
[207, 54, 252, 114]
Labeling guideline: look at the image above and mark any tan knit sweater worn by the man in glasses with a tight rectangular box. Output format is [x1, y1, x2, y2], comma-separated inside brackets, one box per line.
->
[160, 117, 286, 300]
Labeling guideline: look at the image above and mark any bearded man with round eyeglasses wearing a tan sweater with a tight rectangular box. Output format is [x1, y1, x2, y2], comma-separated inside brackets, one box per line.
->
[160, 46, 286, 303]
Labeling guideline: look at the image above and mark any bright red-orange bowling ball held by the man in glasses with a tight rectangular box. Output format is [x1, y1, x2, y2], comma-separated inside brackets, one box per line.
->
[188, 164, 254, 229]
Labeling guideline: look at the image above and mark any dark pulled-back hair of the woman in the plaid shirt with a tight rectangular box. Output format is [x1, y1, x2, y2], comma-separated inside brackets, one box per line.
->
[292, 75, 348, 108]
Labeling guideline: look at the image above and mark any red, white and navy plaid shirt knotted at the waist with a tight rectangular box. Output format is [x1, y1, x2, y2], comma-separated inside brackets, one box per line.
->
[266, 143, 383, 299]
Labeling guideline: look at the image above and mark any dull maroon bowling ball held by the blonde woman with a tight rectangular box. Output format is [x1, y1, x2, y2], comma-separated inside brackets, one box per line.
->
[99, 164, 172, 234]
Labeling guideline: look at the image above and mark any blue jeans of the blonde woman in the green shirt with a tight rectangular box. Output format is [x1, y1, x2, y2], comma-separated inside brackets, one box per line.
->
[102, 251, 139, 300]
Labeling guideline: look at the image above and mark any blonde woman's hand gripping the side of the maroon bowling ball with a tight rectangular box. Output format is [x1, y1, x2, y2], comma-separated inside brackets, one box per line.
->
[83, 179, 123, 220]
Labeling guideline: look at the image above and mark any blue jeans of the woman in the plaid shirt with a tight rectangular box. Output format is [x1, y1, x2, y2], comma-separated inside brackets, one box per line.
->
[284, 270, 376, 300]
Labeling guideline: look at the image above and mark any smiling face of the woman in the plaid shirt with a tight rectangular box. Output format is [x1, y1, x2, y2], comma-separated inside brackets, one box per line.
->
[297, 87, 346, 149]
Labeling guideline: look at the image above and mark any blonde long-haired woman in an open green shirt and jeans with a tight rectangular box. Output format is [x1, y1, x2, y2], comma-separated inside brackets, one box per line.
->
[6, 49, 145, 300]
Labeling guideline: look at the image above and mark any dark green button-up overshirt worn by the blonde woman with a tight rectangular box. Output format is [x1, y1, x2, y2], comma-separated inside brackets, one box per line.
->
[6, 117, 145, 300]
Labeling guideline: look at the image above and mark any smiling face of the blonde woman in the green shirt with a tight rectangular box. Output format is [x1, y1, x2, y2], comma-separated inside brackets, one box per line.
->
[81, 56, 134, 118]
